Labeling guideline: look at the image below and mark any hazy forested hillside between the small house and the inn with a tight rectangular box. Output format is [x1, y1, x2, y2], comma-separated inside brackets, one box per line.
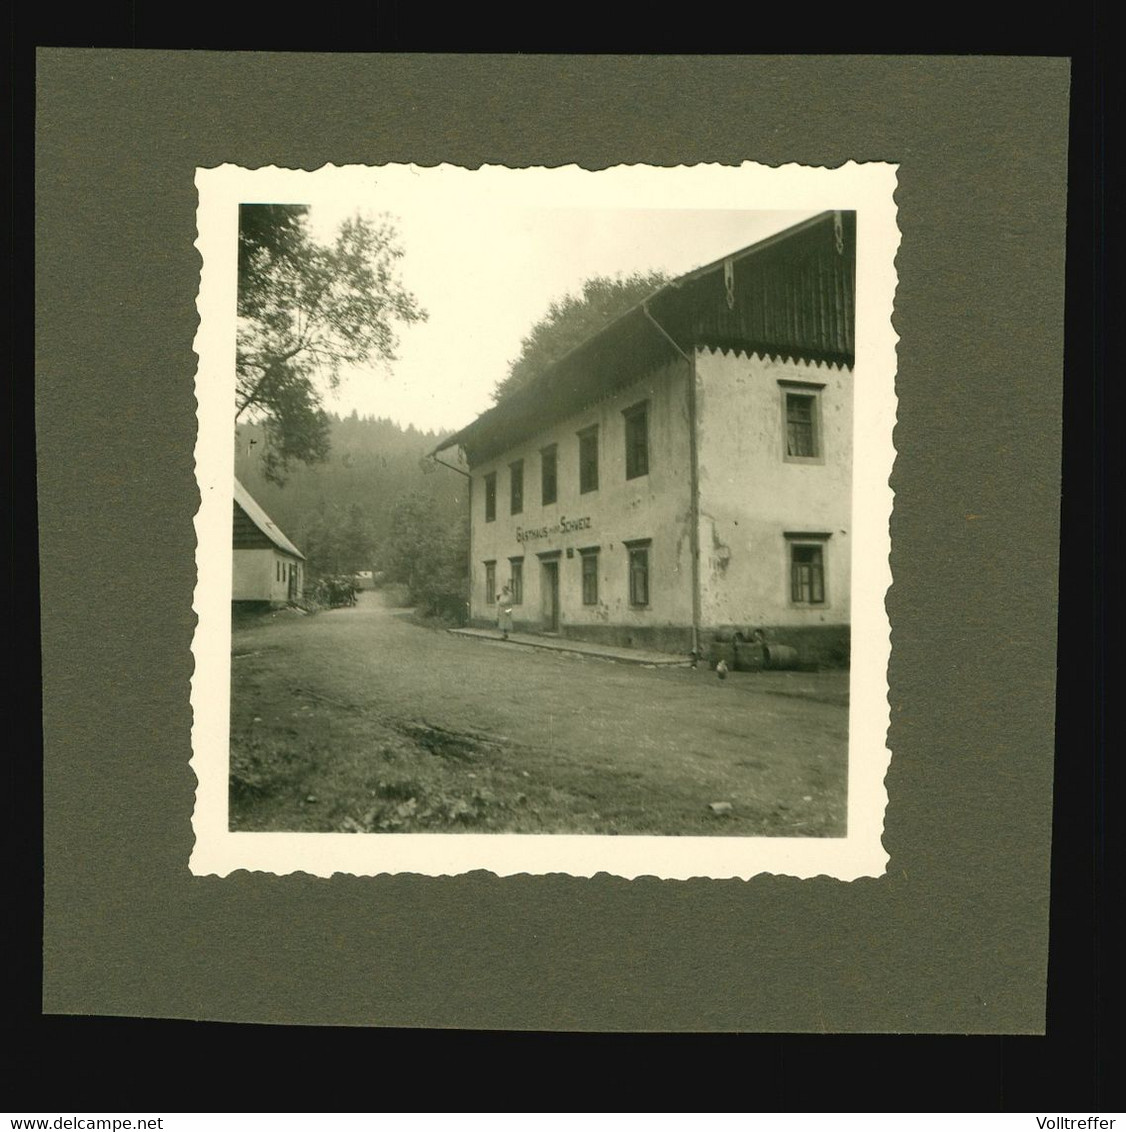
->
[234, 412, 469, 612]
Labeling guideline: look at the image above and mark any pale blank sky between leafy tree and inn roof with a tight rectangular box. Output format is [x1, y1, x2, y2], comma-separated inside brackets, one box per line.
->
[291, 166, 813, 430]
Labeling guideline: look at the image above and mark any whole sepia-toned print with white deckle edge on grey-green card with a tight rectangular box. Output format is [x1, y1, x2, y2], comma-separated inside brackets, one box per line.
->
[192, 164, 897, 878]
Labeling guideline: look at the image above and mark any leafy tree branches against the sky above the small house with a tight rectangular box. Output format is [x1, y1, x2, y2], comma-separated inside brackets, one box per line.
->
[234, 205, 427, 483]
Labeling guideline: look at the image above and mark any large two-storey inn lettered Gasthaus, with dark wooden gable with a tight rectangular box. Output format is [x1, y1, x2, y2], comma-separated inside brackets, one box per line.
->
[437, 212, 856, 663]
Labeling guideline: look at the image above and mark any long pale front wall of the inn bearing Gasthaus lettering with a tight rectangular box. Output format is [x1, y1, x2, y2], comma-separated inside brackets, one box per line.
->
[471, 362, 691, 644]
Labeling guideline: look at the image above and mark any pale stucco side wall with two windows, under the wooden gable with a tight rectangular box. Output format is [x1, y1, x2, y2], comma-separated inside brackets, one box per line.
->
[696, 350, 852, 628]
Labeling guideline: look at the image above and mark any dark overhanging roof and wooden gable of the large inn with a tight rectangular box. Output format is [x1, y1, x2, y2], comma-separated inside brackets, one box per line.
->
[431, 212, 857, 466]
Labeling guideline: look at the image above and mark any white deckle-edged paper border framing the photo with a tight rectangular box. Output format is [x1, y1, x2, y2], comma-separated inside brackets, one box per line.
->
[189, 162, 900, 881]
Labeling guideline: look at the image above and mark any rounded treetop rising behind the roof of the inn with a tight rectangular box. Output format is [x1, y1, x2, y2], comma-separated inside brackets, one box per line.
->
[492, 272, 669, 403]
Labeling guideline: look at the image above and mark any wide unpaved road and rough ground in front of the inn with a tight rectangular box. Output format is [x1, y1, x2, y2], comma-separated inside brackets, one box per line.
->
[231, 593, 848, 837]
